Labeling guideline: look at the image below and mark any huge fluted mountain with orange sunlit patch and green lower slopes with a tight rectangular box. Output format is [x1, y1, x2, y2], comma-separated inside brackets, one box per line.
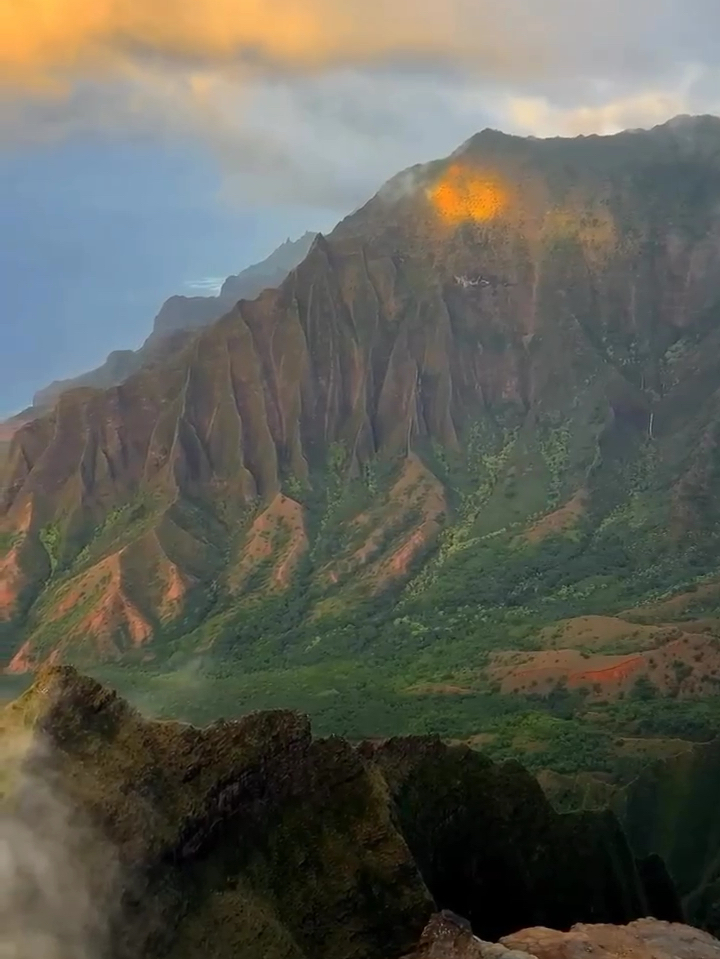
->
[7, 117, 720, 728]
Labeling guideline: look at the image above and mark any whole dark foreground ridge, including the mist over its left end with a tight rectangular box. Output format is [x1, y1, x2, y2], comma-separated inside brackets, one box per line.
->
[0, 667, 688, 959]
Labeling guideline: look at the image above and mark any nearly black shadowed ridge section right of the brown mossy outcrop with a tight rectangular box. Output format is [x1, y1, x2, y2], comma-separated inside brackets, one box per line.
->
[362, 739, 676, 940]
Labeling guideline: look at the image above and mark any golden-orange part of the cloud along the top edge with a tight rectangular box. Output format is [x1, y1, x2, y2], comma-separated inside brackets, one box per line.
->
[0, 0, 537, 89]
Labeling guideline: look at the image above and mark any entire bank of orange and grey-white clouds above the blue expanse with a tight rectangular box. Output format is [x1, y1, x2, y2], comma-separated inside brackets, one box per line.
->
[0, 0, 720, 212]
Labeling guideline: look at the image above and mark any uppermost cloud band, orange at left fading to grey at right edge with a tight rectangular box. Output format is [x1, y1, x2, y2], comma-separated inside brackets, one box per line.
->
[0, 0, 708, 92]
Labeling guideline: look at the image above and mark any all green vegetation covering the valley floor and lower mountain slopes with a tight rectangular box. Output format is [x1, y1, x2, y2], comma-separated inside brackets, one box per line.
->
[25, 402, 720, 779]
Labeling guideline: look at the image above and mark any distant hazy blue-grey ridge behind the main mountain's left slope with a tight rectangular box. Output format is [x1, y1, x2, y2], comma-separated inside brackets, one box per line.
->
[19, 233, 315, 416]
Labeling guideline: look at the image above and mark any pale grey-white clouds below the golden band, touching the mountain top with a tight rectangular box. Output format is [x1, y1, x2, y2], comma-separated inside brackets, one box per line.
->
[7, 0, 720, 213]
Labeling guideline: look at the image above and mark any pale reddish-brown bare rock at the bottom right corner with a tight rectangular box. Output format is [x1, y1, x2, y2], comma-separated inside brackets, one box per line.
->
[405, 913, 720, 959]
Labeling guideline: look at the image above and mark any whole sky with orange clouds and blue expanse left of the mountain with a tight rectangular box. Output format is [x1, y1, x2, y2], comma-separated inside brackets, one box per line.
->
[0, 0, 720, 417]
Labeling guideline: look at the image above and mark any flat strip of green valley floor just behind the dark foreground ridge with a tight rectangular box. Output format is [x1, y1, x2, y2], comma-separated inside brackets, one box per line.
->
[86, 659, 720, 780]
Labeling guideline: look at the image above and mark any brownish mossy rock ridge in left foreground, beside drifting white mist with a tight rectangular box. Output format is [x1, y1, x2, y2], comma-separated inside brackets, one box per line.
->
[0, 669, 432, 959]
